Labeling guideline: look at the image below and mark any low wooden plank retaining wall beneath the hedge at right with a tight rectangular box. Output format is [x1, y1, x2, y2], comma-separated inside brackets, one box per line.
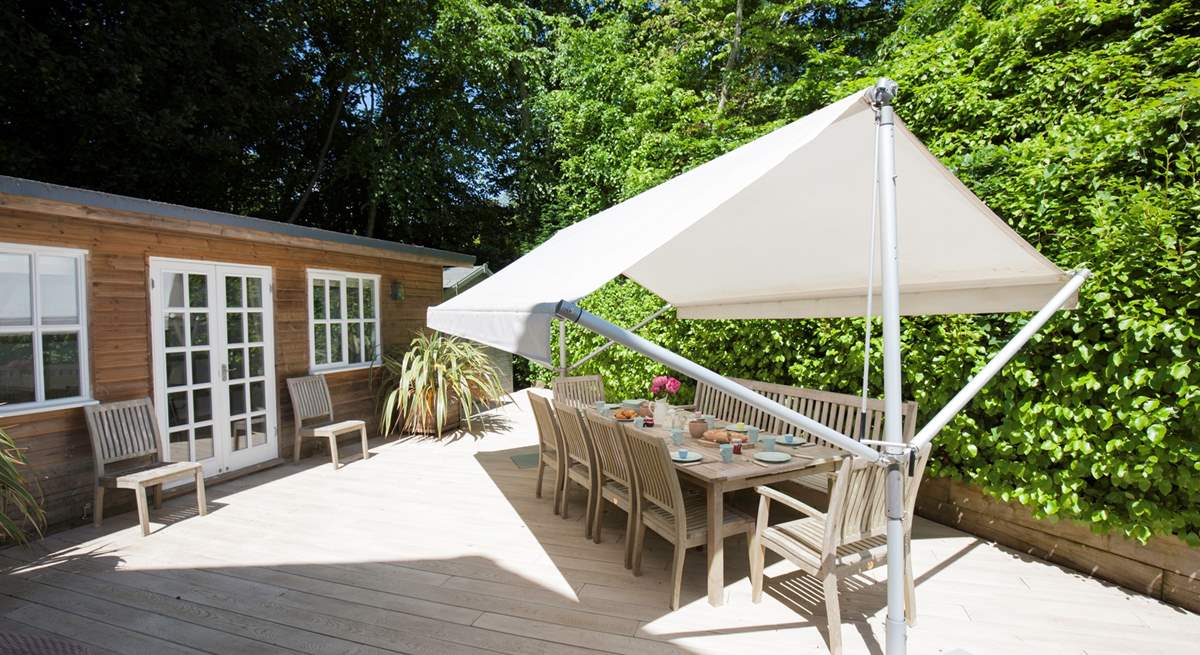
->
[917, 479, 1200, 612]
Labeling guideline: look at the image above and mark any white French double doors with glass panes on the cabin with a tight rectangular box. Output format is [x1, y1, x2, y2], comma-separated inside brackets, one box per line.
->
[150, 258, 278, 475]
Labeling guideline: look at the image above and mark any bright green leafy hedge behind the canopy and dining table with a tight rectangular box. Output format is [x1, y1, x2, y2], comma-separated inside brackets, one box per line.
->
[533, 0, 1200, 543]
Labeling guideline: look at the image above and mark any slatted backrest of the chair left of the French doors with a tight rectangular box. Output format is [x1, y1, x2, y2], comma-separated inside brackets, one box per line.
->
[84, 398, 162, 475]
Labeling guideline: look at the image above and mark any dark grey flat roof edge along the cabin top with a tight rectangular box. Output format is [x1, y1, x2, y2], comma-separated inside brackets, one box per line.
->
[0, 175, 475, 266]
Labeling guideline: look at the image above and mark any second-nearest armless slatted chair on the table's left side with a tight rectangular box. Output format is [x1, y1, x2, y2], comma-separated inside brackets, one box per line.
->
[583, 409, 638, 569]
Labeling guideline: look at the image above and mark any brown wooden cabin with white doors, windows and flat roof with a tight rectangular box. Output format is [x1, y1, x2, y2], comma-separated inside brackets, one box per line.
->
[0, 176, 474, 529]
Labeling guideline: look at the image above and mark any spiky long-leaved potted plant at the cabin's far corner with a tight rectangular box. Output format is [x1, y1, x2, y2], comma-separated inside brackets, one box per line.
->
[380, 332, 504, 437]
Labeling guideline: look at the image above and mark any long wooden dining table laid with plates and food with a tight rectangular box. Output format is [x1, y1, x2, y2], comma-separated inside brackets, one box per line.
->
[642, 421, 846, 607]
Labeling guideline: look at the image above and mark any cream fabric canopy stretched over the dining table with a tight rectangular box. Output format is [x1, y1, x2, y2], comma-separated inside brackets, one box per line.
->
[427, 85, 1074, 363]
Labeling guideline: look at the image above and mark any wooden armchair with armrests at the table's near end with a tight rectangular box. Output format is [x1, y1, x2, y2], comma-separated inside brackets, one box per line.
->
[750, 445, 930, 655]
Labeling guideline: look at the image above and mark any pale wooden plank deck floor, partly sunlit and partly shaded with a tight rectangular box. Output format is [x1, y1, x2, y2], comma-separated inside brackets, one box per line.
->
[0, 393, 1200, 655]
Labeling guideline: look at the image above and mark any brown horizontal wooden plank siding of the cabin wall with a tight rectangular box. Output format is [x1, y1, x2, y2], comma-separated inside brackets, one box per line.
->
[0, 203, 442, 530]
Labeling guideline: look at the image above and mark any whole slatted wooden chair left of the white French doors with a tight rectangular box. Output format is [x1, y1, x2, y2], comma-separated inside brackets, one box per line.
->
[83, 398, 208, 536]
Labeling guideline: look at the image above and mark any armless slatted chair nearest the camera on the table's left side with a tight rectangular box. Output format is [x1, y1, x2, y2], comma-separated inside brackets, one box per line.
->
[624, 423, 754, 609]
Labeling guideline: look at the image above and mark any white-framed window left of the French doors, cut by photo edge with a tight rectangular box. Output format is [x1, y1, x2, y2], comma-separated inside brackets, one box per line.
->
[0, 242, 96, 416]
